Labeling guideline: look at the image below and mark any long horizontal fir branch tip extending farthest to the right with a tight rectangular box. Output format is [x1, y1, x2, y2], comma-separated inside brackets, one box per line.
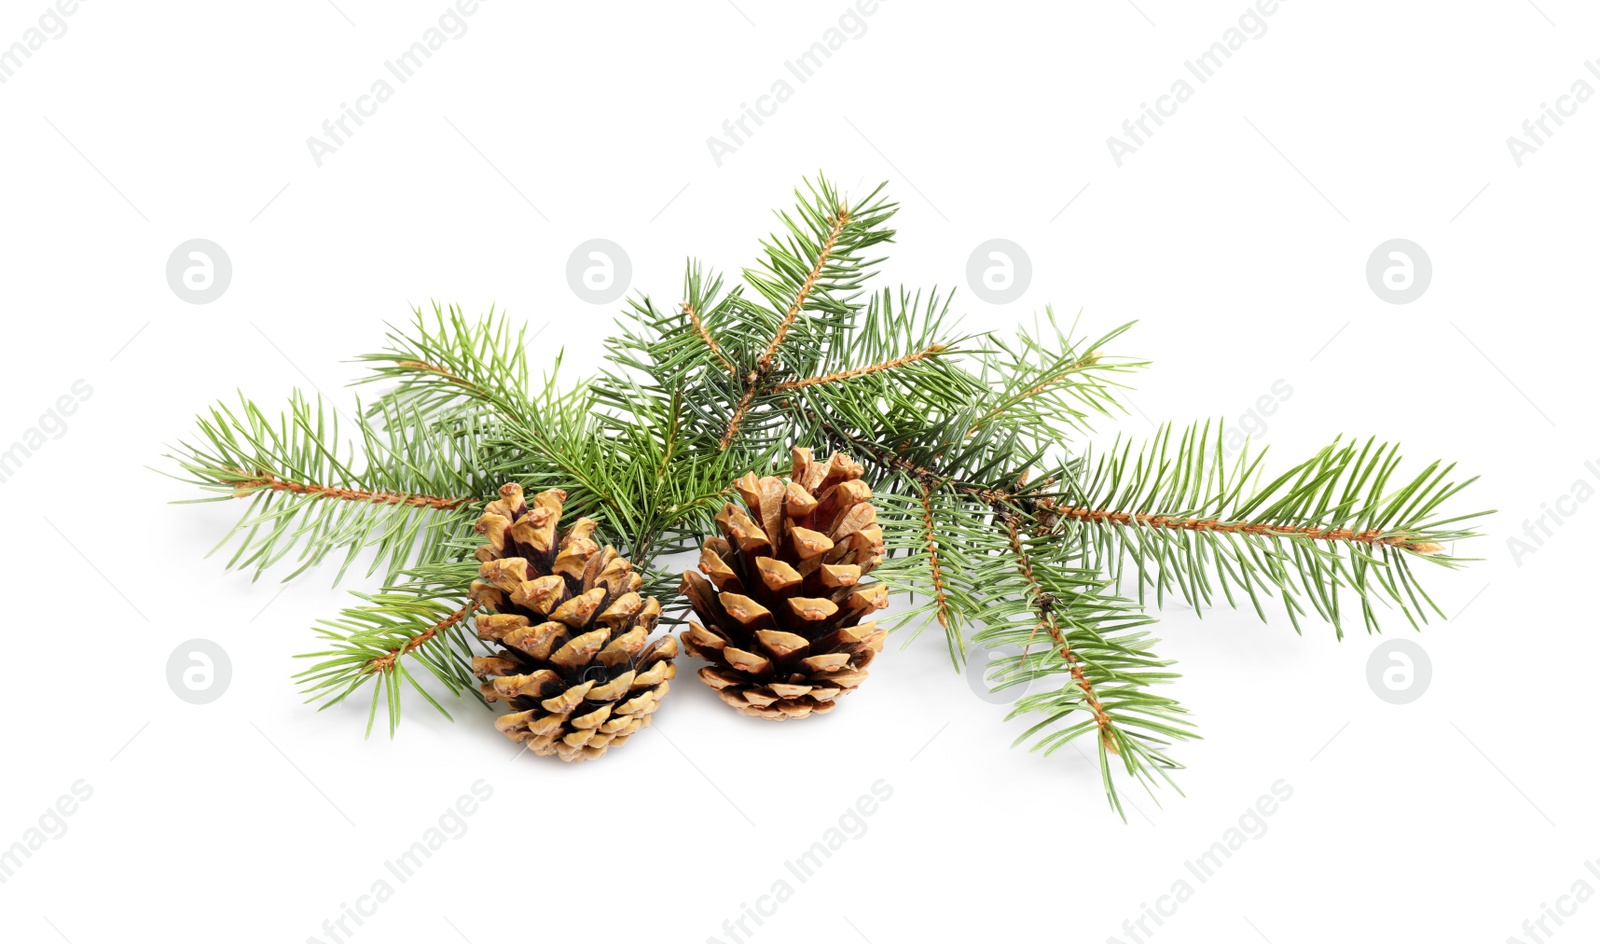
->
[1053, 422, 1490, 637]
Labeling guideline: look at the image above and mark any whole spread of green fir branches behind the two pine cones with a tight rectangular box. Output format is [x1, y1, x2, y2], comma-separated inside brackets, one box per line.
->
[165, 179, 1477, 813]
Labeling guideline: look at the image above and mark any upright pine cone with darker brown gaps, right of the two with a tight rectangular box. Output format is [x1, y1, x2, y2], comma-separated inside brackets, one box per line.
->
[682, 448, 888, 722]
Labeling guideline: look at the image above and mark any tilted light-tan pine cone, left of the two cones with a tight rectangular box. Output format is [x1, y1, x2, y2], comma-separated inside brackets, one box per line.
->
[472, 483, 678, 760]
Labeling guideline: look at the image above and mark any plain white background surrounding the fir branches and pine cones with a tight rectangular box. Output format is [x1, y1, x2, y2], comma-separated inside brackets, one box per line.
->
[0, 0, 1600, 944]
